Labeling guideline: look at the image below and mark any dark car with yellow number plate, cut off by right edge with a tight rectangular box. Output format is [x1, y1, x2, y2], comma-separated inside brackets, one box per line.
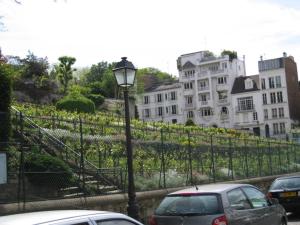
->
[268, 176, 300, 212]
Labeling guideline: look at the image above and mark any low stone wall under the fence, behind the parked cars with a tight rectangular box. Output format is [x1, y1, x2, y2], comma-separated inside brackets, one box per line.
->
[0, 173, 300, 224]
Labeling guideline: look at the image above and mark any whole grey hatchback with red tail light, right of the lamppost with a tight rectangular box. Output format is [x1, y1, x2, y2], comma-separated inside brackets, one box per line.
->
[149, 184, 287, 225]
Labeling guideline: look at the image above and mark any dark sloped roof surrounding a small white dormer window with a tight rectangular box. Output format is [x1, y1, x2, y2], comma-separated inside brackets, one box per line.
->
[231, 75, 259, 94]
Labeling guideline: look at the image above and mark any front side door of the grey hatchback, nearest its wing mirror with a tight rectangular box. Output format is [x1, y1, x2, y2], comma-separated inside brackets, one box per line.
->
[242, 186, 277, 225]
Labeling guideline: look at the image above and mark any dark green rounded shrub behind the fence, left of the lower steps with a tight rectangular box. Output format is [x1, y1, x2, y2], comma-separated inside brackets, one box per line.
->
[24, 153, 74, 188]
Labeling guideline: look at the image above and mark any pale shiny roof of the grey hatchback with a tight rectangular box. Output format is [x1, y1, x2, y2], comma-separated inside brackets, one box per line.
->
[169, 183, 253, 195]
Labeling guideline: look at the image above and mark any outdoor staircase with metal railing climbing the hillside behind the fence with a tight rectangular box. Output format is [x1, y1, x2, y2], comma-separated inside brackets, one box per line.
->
[11, 107, 124, 198]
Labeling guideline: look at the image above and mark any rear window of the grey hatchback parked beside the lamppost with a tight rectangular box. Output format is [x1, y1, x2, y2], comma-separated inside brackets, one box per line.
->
[155, 194, 221, 215]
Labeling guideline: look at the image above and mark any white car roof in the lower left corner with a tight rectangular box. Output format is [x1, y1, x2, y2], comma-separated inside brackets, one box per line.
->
[0, 210, 128, 225]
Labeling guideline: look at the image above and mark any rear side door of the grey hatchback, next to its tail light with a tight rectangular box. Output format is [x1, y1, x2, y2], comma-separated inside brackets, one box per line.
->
[225, 188, 254, 225]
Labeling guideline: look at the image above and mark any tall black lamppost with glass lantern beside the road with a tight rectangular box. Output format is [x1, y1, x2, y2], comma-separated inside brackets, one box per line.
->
[113, 57, 139, 220]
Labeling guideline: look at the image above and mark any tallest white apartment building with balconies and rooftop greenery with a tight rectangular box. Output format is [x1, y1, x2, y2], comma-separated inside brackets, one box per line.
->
[177, 51, 245, 128]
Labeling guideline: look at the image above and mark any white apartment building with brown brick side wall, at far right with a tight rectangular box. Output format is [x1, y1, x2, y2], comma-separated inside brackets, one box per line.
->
[258, 53, 300, 137]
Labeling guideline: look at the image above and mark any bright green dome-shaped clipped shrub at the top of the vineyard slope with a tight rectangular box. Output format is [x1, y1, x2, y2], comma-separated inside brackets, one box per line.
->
[56, 92, 95, 113]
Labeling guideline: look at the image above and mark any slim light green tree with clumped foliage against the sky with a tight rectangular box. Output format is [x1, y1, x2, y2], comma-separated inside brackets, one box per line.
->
[56, 56, 76, 93]
